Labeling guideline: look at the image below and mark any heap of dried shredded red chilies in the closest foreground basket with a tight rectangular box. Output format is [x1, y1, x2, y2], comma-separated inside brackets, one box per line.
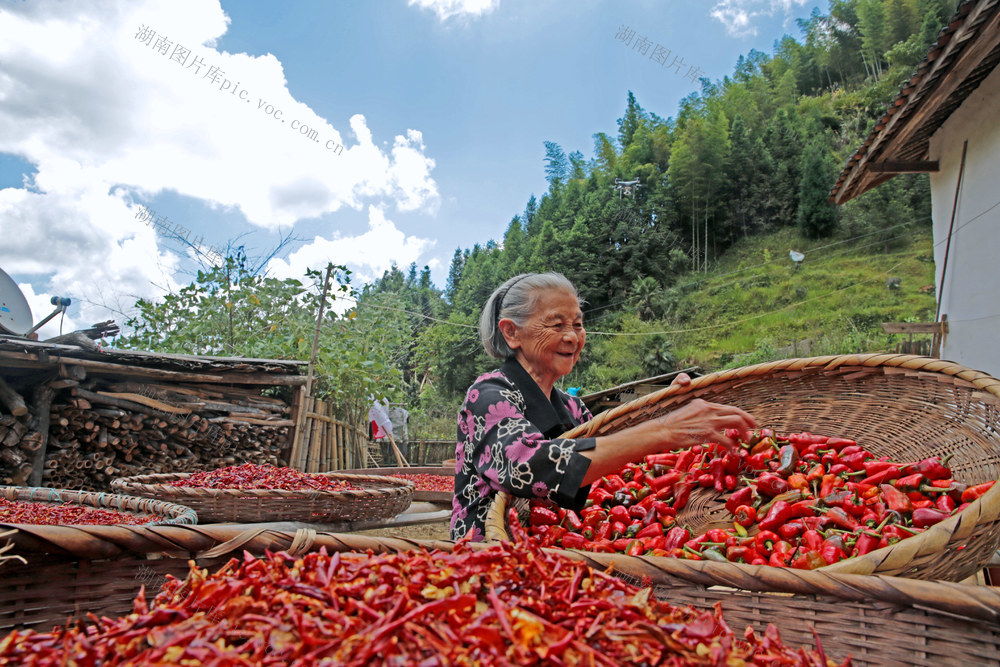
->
[0, 528, 850, 667]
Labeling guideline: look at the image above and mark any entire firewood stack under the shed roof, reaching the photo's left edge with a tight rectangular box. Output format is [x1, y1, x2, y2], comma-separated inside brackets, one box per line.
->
[0, 367, 293, 491]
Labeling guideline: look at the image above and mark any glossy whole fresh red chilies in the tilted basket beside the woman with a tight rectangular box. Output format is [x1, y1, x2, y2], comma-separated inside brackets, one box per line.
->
[530, 429, 995, 569]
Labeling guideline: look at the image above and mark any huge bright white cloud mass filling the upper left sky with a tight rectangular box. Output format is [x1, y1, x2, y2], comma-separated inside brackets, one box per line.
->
[0, 0, 439, 340]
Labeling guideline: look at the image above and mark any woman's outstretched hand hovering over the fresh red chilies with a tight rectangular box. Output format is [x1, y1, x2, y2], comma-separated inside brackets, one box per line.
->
[654, 398, 757, 450]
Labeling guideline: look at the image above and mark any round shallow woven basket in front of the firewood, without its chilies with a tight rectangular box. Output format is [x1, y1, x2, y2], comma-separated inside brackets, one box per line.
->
[111, 473, 414, 523]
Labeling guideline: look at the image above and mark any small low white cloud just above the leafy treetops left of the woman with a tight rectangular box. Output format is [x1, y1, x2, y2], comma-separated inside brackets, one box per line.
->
[267, 206, 435, 285]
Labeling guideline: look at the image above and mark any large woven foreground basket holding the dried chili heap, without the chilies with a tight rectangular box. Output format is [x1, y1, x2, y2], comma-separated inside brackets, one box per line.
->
[0, 524, 1000, 667]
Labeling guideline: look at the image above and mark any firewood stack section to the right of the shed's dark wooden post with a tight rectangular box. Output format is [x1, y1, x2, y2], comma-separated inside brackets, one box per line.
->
[42, 382, 292, 490]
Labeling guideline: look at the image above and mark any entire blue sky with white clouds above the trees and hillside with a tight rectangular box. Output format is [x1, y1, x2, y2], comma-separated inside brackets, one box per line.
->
[0, 0, 826, 333]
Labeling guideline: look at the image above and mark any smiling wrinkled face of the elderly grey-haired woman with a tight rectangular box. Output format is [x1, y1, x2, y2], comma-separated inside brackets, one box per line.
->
[501, 290, 587, 388]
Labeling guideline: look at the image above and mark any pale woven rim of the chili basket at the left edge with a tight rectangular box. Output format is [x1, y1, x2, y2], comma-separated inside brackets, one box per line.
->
[0, 486, 198, 529]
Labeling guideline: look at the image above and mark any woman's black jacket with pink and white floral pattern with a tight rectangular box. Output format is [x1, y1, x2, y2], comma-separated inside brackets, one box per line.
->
[451, 359, 596, 541]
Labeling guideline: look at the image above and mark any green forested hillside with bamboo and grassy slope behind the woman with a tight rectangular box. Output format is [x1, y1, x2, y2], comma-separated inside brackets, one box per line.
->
[119, 0, 956, 436]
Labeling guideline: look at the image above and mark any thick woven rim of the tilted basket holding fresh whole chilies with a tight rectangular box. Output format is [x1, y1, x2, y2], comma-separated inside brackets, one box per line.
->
[486, 353, 1000, 574]
